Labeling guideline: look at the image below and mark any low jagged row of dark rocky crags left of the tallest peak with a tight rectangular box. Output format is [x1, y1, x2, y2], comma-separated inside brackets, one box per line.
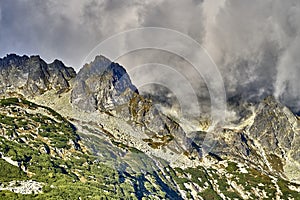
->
[0, 54, 76, 96]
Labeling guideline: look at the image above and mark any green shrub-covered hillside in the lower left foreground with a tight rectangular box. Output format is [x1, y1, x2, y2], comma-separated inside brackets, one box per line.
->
[0, 98, 177, 199]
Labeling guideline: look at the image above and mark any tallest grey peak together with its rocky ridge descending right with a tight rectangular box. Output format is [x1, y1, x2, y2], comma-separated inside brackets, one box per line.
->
[71, 56, 186, 154]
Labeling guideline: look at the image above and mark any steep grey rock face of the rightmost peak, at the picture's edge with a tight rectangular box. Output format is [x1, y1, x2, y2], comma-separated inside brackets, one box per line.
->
[249, 97, 300, 181]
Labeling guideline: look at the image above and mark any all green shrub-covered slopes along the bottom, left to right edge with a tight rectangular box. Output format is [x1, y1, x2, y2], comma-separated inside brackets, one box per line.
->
[0, 98, 299, 200]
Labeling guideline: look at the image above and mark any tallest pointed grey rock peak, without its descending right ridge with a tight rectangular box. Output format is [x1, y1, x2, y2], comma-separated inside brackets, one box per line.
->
[71, 56, 138, 111]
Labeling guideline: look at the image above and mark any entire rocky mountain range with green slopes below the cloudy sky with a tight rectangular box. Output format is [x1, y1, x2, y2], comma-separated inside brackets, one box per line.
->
[0, 54, 300, 199]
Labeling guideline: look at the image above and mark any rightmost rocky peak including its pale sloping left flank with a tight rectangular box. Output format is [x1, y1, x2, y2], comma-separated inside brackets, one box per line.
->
[206, 96, 300, 181]
